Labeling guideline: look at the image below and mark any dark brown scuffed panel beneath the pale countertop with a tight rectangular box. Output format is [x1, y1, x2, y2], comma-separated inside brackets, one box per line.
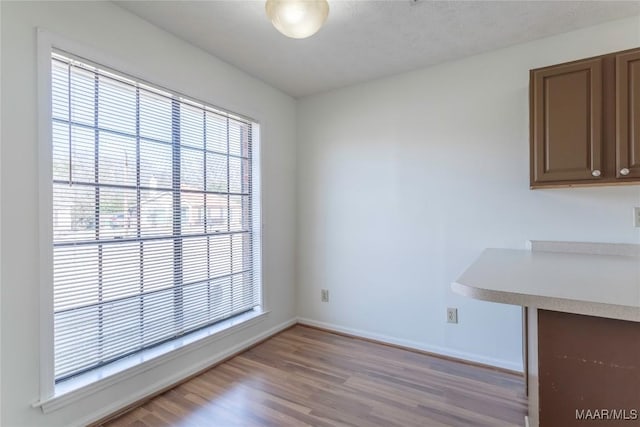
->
[538, 310, 640, 427]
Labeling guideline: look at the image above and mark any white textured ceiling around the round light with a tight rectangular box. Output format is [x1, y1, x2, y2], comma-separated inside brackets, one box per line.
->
[116, 0, 640, 97]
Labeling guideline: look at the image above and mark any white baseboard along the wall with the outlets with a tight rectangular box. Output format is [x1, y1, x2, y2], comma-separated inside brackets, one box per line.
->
[298, 317, 524, 372]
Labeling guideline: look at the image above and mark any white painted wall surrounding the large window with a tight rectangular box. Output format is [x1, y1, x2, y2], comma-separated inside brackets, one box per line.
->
[0, 2, 296, 427]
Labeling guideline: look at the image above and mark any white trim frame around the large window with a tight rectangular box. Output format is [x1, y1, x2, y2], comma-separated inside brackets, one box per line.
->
[33, 28, 269, 413]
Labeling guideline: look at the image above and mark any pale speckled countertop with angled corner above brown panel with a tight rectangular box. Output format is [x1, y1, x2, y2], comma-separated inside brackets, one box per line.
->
[451, 249, 640, 322]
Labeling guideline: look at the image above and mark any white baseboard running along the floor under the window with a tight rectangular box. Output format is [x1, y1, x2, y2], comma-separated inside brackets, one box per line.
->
[77, 318, 297, 426]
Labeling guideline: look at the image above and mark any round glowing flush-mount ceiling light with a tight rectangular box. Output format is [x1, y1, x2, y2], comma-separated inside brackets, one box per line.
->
[265, 0, 329, 39]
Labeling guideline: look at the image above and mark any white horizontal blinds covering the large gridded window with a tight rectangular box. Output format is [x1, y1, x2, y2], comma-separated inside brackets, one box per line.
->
[52, 53, 260, 380]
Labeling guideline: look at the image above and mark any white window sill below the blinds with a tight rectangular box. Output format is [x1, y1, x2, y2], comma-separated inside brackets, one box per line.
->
[33, 307, 269, 413]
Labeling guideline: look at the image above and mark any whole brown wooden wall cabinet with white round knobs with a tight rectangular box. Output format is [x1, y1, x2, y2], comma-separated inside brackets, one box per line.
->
[529, 48, 640, 188]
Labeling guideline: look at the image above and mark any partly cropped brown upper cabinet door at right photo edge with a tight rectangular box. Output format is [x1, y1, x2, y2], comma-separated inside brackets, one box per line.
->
[616, 49, 640, 179]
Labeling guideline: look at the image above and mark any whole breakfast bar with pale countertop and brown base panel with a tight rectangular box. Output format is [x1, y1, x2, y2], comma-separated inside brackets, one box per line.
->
[451, 242, 640, 427]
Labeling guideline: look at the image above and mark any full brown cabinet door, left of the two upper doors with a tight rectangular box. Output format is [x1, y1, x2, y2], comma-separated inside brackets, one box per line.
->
[530, 58, 604, 185]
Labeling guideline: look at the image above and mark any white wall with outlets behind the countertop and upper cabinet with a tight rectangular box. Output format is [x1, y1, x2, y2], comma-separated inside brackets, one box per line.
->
[297, 17, 640, 369]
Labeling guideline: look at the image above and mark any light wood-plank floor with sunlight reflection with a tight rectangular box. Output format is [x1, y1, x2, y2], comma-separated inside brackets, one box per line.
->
[105, 326, 527, 427]
